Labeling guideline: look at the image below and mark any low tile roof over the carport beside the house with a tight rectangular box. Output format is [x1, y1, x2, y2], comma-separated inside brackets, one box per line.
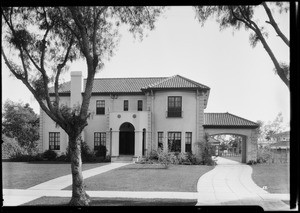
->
[203, 112, 258, 128]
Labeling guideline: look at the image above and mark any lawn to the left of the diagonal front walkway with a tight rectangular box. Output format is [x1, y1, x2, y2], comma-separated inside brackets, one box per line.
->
[2, 162, 107, 189]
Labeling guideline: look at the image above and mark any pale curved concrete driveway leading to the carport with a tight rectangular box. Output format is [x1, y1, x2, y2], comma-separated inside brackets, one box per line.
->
[197, 157, 289, 210]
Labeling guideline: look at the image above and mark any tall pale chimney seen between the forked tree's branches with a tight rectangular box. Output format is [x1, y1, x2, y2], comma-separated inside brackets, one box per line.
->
[70, 71, 83, 107]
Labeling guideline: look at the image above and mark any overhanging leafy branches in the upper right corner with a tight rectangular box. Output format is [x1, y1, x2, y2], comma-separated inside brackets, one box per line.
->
[195, 2, 290, 88]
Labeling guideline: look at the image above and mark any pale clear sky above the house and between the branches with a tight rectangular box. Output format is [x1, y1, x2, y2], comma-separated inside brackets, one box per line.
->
[2, 6, 290, 128]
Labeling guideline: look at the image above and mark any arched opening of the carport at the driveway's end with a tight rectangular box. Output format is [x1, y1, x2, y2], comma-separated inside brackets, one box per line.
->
[209, 133, 247, 163]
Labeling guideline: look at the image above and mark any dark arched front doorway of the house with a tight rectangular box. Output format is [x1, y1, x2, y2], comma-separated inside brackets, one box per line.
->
[119, 122, 134, 155]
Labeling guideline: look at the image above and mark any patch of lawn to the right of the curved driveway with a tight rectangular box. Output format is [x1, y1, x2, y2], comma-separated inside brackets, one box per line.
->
[251, 163, 290, 194]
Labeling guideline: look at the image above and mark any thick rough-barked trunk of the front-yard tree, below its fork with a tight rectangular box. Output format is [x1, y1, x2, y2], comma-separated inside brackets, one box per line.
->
[69, 135, 90, 206]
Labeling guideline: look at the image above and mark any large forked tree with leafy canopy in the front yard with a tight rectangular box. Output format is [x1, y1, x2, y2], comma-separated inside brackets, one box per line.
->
[1, 6, 162, 205]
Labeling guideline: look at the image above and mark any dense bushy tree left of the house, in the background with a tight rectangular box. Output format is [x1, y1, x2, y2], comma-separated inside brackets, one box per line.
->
[2, 100, 39, 150]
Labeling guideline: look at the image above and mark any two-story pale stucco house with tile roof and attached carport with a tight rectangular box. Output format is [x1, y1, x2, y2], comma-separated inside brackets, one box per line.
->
[40, 72, 258, 162]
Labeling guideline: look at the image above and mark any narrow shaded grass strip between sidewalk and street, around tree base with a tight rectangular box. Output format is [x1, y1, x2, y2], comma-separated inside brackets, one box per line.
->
[22, 197, 197, 206]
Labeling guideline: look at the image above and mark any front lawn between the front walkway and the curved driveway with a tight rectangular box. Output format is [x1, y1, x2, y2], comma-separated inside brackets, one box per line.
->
[65, 164, 214, 192]
